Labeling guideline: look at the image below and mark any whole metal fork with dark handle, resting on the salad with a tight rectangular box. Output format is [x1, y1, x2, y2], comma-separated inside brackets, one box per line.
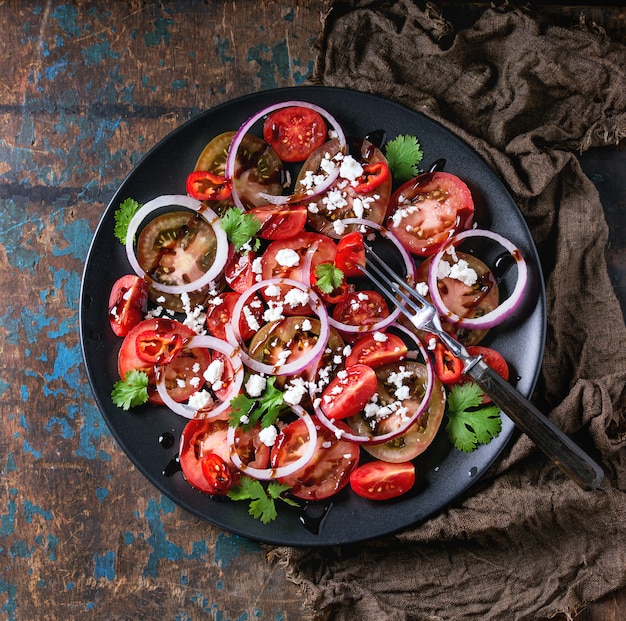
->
[359, 244, 604, 490]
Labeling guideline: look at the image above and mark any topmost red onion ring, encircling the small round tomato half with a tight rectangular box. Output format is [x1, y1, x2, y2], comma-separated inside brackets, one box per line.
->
[224, 101, 346, 210]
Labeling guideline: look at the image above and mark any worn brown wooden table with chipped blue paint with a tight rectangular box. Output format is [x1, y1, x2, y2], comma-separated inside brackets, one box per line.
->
[0, 0, 626, 621]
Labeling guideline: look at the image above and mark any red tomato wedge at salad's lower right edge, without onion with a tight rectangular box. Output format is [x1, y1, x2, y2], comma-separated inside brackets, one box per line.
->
[350, 460, 415, 500]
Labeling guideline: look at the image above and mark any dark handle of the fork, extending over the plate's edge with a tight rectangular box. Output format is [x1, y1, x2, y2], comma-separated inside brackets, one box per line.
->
[467, 359, 604, 490]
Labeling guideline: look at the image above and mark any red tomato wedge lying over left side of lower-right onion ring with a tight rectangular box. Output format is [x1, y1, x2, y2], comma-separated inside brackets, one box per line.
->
[320, 364, 378, 419]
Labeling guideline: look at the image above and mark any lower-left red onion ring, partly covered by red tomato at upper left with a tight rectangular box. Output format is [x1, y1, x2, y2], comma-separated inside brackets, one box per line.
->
[157, 335, 244, 420]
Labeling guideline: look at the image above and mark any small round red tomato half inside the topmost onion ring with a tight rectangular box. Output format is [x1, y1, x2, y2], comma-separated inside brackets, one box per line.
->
[263, 106, 327, 162]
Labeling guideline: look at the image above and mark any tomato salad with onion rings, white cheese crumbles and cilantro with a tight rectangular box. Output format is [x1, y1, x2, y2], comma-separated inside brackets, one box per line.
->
[108, 101, 526, 522]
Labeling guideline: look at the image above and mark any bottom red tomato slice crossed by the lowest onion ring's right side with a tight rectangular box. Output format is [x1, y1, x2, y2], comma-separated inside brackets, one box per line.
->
[270, 419, 359, 500]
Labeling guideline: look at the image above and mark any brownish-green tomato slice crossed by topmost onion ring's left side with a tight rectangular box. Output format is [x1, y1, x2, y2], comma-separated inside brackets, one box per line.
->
[194, 131, 283, 215]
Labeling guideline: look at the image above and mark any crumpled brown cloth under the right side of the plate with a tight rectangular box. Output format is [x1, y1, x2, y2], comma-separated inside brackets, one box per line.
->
[270, 0, 626, 621]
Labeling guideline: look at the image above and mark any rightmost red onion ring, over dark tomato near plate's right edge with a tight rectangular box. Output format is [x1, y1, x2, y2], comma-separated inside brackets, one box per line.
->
[428, 229, 528, 329]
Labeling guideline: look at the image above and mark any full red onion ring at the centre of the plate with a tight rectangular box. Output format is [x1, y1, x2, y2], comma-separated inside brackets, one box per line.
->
[225, 278, 330, 375]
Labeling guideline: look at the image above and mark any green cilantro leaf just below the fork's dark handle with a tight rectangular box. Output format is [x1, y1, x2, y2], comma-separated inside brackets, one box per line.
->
[446, 382, 502, 453]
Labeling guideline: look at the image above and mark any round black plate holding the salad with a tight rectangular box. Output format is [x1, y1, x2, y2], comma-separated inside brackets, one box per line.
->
[80, 87, 546, 546]
